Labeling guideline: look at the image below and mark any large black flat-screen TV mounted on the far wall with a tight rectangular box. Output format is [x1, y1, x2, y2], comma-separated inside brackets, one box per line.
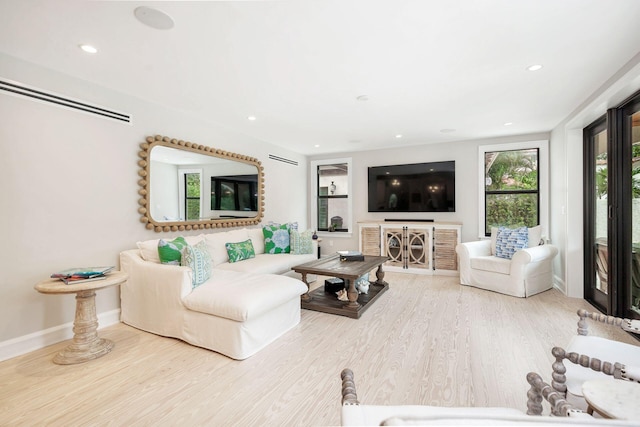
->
[369, 161, 456, 212]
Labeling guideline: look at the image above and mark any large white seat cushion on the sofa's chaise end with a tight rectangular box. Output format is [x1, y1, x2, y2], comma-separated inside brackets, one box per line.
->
[182, 270, 307, 322]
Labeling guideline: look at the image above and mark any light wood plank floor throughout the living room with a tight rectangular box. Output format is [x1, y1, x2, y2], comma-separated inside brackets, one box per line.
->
[0, 273, 637, 426]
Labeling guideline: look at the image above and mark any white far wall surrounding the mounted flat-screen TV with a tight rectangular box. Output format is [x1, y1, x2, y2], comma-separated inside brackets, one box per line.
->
[310, 133, 549, 253]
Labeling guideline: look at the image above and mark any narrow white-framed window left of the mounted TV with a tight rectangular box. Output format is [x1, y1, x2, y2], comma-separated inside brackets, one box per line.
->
[310, 158, 352, 233]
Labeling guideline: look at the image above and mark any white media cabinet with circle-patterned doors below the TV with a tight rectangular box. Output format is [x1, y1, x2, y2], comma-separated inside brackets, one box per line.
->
[360, 221, 462, 275]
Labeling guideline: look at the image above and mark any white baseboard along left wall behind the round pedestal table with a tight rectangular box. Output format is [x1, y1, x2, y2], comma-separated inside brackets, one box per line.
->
[0, 308, 120, 362]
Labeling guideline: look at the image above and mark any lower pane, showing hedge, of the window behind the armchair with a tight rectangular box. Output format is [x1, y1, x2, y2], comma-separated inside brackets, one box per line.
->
[485, 193, 538, 234]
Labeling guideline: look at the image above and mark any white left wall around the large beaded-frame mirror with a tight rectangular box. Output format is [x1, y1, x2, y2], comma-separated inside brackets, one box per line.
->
[0, 51, 308, 359]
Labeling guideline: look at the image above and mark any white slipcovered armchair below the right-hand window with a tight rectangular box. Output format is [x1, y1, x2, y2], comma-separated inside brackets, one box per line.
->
[456, 231, 558, 297]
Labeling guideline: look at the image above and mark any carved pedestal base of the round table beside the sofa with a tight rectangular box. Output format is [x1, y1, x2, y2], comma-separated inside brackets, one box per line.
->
[53, 290, 114, 365]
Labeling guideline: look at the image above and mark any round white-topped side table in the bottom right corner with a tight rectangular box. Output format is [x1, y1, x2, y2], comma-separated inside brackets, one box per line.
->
[582, 379, 640, 421]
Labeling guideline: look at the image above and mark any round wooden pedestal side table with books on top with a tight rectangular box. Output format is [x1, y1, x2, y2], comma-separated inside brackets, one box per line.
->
[34, 271, 129, 365]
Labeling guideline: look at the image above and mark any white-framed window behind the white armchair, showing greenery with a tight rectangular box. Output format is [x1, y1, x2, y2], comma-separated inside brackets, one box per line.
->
[478, 141, 549, 237]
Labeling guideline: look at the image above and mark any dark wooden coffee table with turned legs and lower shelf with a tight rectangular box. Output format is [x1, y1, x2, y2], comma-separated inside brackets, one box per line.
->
[292, 254, 389, 319]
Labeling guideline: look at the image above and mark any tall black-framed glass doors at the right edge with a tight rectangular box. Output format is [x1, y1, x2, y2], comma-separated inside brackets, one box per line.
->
[584, 88, 640, 319]
